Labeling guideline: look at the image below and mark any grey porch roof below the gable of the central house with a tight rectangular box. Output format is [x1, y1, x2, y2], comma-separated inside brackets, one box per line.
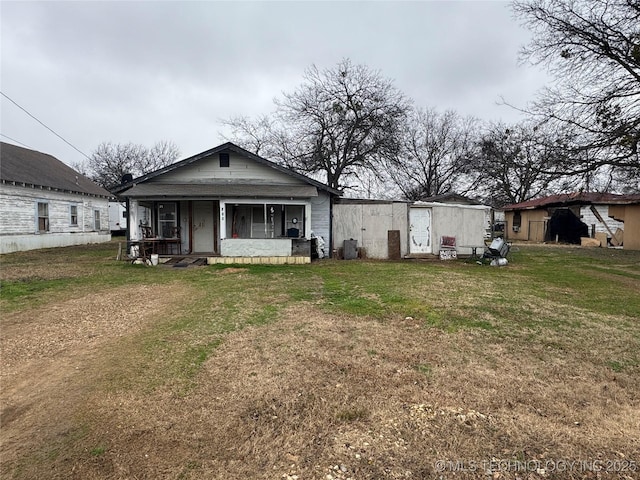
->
[121, 183, 318, 198]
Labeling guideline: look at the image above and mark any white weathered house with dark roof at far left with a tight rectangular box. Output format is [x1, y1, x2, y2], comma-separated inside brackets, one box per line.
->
[0, 142, 111, 253]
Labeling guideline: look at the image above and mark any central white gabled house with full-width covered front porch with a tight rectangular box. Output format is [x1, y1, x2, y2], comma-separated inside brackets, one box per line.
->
[114, 143, 341, 263]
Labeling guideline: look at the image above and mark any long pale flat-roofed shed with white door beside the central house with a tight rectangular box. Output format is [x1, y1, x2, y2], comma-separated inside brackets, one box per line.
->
[333, 198, 487, 259]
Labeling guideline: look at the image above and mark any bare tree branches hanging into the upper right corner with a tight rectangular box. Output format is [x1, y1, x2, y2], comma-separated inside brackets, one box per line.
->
[513, 0, 640, 179]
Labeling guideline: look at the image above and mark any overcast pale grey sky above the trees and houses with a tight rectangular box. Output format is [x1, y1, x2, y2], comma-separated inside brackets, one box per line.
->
[0, 0, 546, 169]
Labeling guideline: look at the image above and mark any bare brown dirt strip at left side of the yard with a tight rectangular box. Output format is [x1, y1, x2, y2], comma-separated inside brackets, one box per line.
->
[0, 285, 192, 465]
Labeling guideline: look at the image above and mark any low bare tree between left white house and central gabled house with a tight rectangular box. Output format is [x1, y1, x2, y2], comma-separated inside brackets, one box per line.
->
[87, 141, 180, 189]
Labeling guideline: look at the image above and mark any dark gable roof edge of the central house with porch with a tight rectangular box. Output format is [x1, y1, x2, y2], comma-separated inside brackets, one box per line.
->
[112, 142, 342, 195]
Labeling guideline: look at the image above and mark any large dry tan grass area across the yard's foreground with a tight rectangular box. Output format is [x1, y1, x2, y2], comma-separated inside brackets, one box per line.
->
[56, 304, 640, 479]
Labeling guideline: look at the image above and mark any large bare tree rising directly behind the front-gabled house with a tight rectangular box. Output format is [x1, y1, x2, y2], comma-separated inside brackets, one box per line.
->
[225, 59, 410, 189]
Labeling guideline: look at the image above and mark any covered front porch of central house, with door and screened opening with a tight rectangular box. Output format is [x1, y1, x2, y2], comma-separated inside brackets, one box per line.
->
[127, 197, 312, 263]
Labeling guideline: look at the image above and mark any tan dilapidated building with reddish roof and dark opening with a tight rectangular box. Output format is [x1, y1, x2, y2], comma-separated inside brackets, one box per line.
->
[504, 192, 640, 250]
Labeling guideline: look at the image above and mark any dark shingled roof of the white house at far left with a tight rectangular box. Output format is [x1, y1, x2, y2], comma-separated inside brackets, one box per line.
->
[0, 142, 111, 198]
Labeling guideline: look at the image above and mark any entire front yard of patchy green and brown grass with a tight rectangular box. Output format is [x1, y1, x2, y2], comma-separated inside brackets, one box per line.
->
[0, 241, 640, 480]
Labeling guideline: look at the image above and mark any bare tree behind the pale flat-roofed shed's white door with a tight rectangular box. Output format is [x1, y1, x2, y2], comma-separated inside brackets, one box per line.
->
[388, 109, 477, 200]
